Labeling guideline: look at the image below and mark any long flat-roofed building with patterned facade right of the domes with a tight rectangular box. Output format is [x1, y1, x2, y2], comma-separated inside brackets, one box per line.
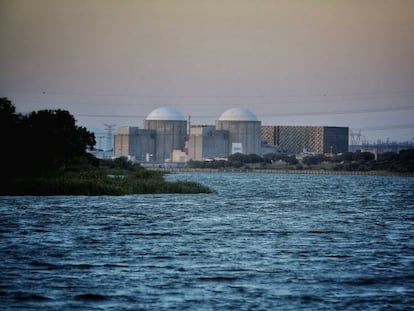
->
[262, 125, 349, 154]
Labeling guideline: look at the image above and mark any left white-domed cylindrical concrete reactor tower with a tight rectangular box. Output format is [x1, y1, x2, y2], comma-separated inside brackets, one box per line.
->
[144, 107, 187, 163]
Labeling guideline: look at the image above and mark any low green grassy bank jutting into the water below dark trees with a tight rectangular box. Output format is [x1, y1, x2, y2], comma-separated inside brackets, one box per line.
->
[0, 169, 213, 196]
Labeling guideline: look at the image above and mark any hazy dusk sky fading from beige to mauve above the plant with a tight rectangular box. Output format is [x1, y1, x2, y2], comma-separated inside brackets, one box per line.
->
[0, 0, 414, 146]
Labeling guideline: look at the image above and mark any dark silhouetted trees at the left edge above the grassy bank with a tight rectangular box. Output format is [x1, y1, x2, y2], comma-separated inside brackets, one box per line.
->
[0, 98, 95, 177]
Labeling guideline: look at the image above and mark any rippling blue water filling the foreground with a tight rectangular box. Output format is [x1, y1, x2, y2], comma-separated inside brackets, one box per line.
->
[0, 173, 414, 310]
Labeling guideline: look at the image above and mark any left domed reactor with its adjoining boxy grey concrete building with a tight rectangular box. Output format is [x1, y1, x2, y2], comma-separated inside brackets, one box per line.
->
[114, 107, 187, 163]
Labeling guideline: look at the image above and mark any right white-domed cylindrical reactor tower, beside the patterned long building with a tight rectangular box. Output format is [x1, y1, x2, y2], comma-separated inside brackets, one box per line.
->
[216, 108, 261, 154]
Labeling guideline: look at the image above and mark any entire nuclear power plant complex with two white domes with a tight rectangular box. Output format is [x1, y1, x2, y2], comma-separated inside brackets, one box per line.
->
[114, 107, 349, 163]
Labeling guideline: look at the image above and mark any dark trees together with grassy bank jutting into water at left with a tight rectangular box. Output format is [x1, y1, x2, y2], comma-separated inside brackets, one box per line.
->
[0, 98, 211, 195]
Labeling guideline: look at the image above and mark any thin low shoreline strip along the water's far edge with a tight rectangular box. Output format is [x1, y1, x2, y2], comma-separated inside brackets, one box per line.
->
[148, 167, 414, 177]
